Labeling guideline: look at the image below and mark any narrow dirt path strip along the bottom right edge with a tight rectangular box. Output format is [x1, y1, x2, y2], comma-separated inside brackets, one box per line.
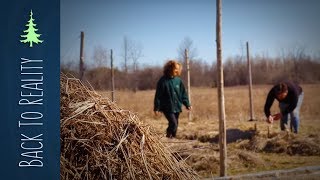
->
[203, 166, 320, 180]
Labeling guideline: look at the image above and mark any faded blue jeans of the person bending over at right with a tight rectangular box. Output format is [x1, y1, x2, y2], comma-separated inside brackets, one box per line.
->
[279, 92, 304, 133]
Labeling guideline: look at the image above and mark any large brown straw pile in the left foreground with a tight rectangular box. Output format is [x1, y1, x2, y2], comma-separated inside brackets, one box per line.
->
[60, 74, 198, 180]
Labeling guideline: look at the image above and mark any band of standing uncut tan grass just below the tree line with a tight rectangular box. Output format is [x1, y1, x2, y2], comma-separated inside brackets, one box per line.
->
[105, 84, 320, 121]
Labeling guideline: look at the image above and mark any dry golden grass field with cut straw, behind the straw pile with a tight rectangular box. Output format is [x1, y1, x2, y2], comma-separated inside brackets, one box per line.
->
[98, 84, 320, 177]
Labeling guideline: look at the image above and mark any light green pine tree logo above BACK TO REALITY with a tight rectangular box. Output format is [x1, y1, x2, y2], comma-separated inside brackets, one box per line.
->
[20, 10, 43, 47]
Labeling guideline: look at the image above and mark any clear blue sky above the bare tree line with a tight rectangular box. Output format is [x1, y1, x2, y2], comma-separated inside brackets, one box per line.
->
[61, 0, 320, 66]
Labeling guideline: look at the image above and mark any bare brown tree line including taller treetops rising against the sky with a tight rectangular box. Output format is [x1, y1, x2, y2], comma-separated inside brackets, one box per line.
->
[61, 36, 320, 91]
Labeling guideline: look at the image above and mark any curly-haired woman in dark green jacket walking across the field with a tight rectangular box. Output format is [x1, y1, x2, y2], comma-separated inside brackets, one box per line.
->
[153, 60, 192, 138]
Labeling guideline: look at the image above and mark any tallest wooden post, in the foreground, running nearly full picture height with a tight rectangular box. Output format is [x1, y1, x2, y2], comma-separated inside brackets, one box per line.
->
[216, 0, 227, 177]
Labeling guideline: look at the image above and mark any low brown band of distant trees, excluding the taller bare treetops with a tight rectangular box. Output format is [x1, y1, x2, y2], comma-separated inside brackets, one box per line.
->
[61, 55, 320, 90]
